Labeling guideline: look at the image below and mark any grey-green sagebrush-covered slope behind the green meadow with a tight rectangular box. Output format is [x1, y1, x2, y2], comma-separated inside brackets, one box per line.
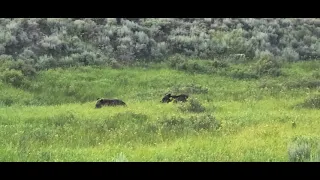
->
[0, 18, 320, 70]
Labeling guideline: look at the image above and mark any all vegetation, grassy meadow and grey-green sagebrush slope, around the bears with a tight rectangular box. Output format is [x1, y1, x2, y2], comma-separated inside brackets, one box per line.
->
[0, 18, 320, 162]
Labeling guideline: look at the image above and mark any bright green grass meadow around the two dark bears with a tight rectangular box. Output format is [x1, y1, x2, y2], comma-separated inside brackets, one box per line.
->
[0, 61, 320, 161]
